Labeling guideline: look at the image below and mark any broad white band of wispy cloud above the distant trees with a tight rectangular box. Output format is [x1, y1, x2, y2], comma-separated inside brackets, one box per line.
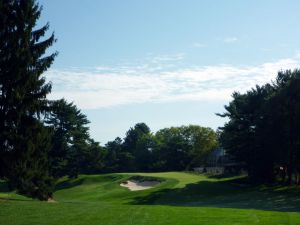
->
[46, 55, 300, 109]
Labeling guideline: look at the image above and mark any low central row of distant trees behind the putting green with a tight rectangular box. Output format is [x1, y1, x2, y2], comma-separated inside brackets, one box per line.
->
[105, 123, 217, 172]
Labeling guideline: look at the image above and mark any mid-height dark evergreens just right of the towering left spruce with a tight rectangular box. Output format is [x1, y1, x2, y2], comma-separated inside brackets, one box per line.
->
[46, 99, 104, 177]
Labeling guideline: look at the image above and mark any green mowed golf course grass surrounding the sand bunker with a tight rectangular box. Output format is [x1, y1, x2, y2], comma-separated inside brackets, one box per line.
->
[0, 172, 300, 225]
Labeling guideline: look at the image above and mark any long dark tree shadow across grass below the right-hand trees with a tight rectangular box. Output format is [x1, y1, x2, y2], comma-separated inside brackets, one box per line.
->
[130, 178, 300, 212]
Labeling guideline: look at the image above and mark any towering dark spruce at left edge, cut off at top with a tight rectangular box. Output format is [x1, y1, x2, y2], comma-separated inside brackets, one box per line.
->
[0, 0, 57, 200]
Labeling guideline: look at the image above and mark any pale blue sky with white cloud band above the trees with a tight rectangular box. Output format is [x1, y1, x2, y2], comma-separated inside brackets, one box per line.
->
[37, 0, 300, 145]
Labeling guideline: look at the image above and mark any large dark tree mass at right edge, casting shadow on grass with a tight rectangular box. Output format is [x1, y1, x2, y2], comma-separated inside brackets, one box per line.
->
[220, 70, 300, 184]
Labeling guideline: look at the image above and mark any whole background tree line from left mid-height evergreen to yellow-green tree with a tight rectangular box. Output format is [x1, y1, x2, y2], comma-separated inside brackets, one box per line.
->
[45, 106, 218, 178]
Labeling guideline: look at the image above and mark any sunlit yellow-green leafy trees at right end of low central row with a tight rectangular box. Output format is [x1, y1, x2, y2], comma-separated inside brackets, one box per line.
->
[154, 125, 217, 171]
